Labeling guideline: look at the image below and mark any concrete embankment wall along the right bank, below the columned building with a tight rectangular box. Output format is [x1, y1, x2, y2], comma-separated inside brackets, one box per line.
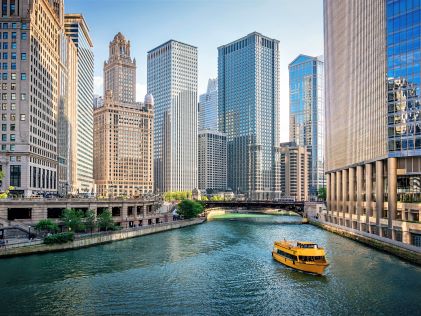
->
[309, 219, 421, 265]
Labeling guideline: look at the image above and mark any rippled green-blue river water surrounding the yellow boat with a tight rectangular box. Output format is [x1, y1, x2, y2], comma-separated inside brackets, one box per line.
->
[0, 216, 421, 316]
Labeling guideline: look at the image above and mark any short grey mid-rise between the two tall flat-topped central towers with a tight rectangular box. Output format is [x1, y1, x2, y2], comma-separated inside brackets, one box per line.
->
[198, 130, 227, 191]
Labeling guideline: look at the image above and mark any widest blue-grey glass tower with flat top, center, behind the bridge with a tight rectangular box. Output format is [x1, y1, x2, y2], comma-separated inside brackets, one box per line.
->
[218, 33, 280, 199]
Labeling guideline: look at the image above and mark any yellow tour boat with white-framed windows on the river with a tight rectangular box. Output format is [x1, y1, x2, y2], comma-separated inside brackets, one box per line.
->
[272, 240, 329, 274]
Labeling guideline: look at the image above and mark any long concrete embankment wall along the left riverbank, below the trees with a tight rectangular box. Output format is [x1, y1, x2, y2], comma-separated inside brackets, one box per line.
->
[0, 218, 205, 258]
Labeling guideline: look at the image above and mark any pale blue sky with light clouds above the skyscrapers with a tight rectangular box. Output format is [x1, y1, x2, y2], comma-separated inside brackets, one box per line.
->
[65, 0, 323, 142]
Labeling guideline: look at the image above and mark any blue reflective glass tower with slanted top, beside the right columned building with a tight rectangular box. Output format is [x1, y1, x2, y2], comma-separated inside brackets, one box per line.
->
[288, 55, 325, 197]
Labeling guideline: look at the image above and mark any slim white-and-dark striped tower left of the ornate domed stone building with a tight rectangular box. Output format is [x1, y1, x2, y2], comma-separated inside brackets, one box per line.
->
[64, 14, 94, 193]
